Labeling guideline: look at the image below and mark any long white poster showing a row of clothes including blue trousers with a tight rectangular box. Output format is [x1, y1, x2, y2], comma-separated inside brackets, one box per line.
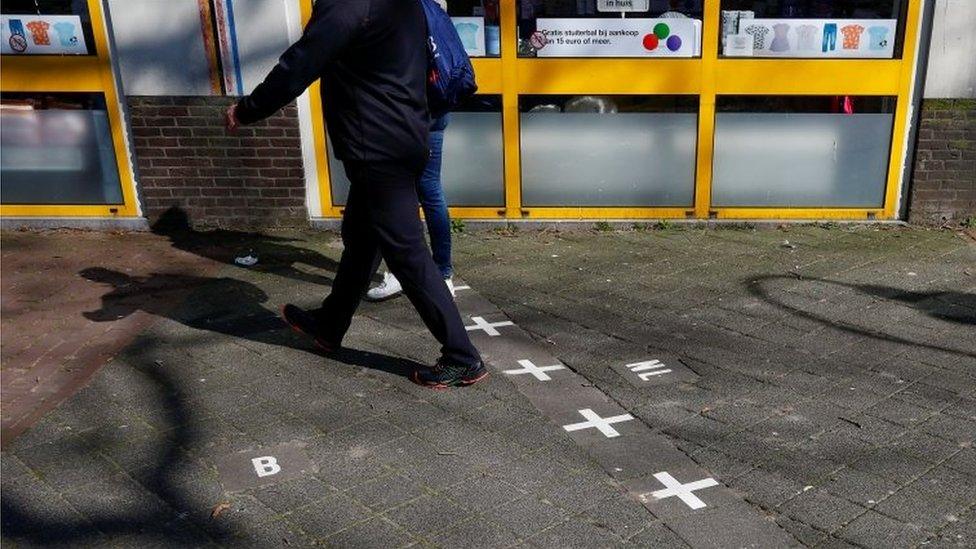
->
[725, 19, 898, 59]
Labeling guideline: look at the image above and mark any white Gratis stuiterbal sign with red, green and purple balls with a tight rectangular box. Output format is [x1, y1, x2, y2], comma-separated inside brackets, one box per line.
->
[529, 18, 700, 57]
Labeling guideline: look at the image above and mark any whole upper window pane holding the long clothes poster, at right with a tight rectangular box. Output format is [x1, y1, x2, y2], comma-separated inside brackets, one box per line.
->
[721, 0, 908, 59]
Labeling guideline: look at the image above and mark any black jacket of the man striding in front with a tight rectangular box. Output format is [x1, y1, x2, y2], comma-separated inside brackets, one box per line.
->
[237, 0, 428, 163]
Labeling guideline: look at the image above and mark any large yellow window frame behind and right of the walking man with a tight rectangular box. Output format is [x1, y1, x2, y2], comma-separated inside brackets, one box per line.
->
[300, 0, 923, 220]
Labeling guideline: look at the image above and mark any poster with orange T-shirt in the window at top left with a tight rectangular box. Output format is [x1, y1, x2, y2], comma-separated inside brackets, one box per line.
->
[0, 15, 88, 55]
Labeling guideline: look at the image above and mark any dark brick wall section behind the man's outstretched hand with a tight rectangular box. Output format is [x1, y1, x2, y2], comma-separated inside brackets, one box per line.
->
[128, 97, 308, 228]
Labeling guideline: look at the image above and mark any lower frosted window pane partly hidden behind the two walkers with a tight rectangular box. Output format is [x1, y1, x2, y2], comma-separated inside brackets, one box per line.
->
[329, 95, 505, 207]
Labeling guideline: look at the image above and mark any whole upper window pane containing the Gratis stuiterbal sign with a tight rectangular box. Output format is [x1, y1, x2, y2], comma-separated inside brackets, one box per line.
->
[517, 0, 703, 57]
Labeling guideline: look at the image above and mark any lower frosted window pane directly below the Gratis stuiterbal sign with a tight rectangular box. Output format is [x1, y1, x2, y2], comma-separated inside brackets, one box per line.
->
[519, 95, 698, 206]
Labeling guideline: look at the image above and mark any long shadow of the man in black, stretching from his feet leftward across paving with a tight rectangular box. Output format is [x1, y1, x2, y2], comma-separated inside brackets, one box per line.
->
[79, 267, 422, 378]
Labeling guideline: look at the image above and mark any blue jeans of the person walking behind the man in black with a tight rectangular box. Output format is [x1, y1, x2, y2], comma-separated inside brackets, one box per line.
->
[417, 115, 454, 278]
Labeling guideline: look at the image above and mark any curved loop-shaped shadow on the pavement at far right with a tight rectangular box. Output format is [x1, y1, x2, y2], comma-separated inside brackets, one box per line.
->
[745, 275, 976, 358]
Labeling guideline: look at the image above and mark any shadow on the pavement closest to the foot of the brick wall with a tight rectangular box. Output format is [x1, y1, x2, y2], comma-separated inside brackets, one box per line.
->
[152, 206, 339, 285]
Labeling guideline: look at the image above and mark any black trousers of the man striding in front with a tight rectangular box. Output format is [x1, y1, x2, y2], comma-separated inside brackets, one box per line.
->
[318, 162, 481, 365]
